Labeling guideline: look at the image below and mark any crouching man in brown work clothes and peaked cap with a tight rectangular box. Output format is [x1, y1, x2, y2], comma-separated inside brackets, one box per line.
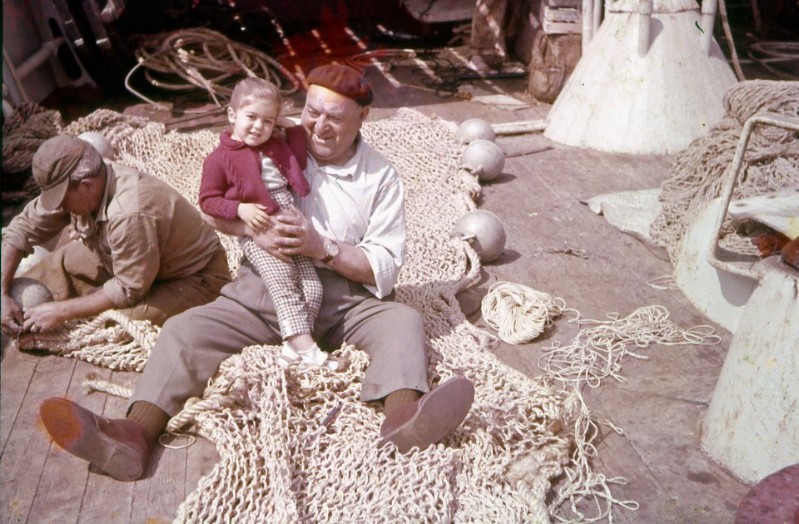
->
[2, 135, 230, 334]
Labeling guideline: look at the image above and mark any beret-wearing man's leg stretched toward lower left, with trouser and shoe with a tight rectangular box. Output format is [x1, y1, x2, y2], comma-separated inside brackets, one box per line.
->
[40, 271, 279, 480]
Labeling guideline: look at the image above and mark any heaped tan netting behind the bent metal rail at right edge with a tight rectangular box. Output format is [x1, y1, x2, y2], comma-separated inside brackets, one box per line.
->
[650, 80, 799, 259]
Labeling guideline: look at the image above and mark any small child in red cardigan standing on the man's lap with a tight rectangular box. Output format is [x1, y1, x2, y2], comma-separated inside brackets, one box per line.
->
[200, 78, 343, 371]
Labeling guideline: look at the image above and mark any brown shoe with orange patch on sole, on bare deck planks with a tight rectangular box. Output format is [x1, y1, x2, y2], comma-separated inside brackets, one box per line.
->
[39, 397, 150, 481]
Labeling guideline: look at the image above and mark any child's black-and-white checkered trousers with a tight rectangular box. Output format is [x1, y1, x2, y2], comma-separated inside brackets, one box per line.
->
[241, 188, 322, 340]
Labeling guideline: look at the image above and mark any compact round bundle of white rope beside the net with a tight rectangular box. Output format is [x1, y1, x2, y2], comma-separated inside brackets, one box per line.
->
[482, 282, 566, 344]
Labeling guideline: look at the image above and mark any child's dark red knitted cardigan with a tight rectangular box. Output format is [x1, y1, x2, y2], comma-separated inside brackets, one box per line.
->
[200, 126, 310, 220]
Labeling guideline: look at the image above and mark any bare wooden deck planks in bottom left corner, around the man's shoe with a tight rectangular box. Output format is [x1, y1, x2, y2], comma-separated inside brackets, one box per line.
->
[0, 345, 218, 524]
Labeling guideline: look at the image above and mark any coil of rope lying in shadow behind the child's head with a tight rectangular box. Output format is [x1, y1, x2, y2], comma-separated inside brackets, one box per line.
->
[125, 28, 300, 109]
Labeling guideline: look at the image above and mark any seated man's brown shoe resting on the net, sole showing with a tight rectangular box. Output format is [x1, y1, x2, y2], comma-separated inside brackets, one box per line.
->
[380, 377, 474, 453]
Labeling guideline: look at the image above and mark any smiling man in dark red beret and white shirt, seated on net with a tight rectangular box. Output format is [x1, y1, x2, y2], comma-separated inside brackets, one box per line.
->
[40, 65, 474, 480]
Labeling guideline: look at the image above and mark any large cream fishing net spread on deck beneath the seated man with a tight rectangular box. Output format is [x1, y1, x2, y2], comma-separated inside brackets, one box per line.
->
[14, 109, 600, 522]
